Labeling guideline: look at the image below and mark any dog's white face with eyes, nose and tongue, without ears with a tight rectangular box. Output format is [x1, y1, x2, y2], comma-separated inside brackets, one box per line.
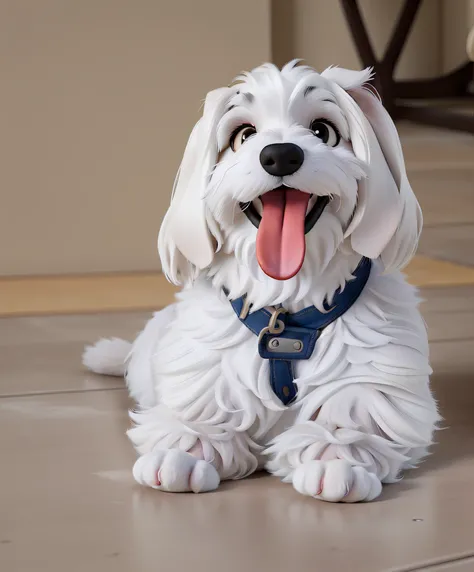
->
[205, 72, 365, 280]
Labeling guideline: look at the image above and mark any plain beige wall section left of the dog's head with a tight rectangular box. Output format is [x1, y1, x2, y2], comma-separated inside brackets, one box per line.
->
[0, 0, 270, 275]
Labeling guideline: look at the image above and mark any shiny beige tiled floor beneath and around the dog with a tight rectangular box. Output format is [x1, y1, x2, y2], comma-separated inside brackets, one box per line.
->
[0, 122, 474, 572]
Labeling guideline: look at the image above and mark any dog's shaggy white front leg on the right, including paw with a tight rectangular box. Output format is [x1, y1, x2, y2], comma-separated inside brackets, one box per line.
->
[266, 380, 439, 502]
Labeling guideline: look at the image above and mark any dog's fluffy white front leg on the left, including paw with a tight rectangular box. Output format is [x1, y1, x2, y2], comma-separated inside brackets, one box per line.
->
[128, 405, 258, 493]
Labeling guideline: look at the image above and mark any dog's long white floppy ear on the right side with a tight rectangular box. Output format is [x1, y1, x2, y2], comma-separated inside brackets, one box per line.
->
[332, 80, 422, 271]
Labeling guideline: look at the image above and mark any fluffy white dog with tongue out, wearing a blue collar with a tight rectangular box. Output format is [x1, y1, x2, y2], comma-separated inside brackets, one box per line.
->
[84, 61, 439, 502]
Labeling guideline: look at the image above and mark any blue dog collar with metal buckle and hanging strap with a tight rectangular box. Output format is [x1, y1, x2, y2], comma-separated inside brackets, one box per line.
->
[231, 258, 372, 405]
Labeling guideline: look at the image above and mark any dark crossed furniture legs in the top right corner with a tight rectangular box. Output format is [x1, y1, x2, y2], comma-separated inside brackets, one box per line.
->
[341, 0, 474, 133]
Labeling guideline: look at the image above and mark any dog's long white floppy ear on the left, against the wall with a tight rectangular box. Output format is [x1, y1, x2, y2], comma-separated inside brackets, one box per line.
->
[158, 88, 231, 284]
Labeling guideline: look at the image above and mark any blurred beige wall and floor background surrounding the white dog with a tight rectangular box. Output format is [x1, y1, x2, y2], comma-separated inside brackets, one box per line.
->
[0, 4, 474, 572]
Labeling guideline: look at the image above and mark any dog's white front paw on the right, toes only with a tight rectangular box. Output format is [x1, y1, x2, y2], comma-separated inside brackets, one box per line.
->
[293, 459, 382, 502]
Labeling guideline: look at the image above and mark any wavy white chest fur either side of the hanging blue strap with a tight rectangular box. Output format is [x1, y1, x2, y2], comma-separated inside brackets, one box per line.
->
[148, 264, 429, 445]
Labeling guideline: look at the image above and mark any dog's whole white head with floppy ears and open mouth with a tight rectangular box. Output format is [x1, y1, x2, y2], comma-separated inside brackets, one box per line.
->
[158, 62, 422, 283]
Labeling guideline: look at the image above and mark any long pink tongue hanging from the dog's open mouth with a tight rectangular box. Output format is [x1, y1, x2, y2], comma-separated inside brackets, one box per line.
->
[257, 188, 310, 280]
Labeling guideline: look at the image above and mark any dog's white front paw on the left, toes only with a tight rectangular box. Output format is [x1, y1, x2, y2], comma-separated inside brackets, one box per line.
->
[133, 449, 220, 493]
